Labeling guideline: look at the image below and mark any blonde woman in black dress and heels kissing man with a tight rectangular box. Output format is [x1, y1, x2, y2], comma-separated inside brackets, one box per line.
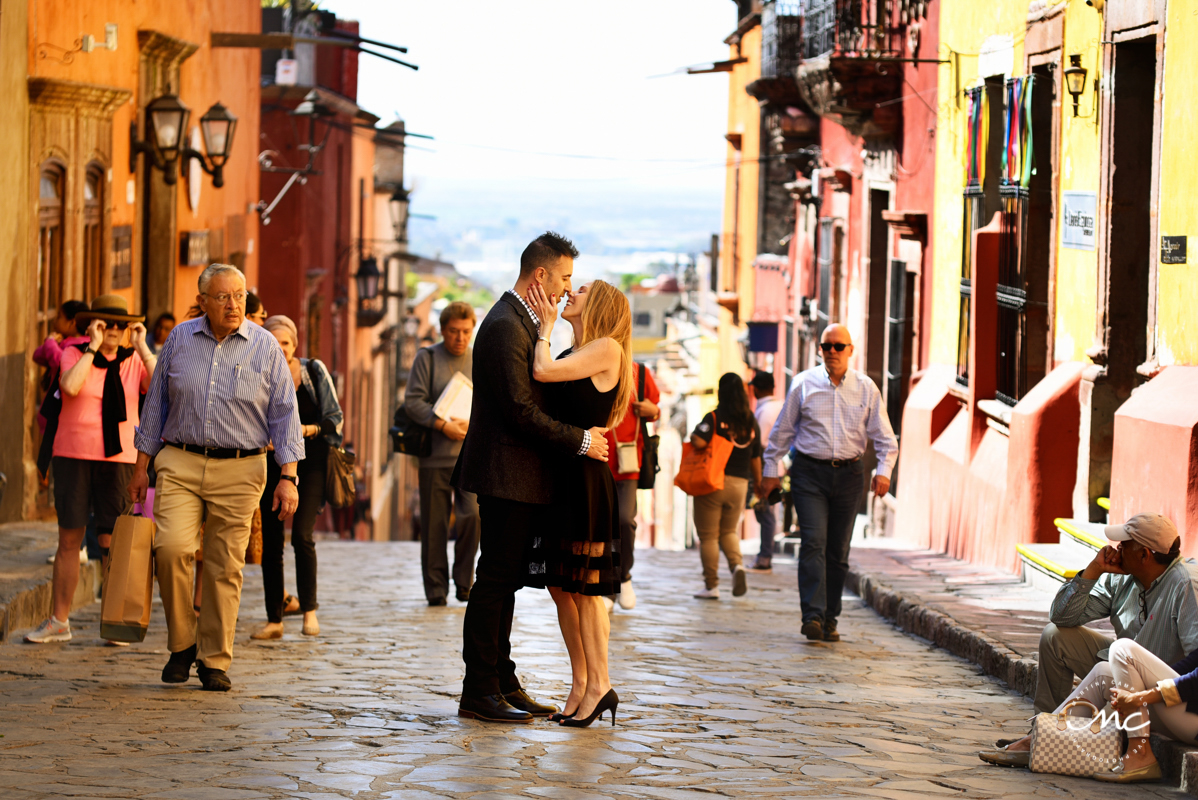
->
[528, 280, 633, 727]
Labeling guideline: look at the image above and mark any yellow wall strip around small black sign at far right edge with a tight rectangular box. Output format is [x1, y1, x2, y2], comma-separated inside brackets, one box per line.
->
[1154, 2, 1198, 365]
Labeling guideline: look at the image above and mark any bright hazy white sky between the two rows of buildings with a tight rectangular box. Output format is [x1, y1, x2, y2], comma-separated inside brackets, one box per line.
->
[322, 0, 736, 259]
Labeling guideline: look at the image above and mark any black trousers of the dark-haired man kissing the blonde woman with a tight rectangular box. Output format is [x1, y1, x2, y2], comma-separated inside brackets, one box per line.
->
[461, 495, 549, 697]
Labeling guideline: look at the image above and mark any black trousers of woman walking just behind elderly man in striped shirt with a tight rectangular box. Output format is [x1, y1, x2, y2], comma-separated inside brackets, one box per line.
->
[259, 453, 325, 623]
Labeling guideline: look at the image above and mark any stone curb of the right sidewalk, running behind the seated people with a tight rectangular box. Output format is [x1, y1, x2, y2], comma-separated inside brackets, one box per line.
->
[845, 568, 1198, 798]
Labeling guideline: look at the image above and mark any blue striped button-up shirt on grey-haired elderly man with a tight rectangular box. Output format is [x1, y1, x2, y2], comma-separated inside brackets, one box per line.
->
[134, 316, 304, 465]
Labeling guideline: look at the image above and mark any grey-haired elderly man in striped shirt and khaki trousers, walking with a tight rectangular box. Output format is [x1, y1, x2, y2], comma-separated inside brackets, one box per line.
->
[129, 263, 304, 691]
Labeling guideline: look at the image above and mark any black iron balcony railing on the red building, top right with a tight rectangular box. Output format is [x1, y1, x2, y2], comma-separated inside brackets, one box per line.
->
[803, 0, 902, 59]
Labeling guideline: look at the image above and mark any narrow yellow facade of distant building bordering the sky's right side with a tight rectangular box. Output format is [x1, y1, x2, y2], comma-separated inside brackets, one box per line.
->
[720, 25, 761, 372]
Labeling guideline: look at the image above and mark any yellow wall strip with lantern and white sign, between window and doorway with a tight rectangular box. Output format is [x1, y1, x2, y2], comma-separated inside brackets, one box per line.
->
[1053, 0, 1103, 363]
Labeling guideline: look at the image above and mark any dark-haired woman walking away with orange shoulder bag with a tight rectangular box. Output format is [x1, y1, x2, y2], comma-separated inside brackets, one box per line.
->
[690, 372, 762, 600]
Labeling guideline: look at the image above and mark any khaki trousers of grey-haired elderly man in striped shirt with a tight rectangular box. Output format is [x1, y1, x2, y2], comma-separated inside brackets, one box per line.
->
[153, 447, 266, 671]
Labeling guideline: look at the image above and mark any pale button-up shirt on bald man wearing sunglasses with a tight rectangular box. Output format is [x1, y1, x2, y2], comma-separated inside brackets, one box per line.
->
[761, 366, 899, 478]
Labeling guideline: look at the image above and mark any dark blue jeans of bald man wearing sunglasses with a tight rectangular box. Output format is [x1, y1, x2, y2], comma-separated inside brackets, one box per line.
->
[791, 456, 865, 626]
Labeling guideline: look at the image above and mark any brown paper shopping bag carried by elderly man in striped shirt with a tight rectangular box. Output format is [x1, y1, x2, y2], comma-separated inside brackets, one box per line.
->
[99, 505, 156, 642]
